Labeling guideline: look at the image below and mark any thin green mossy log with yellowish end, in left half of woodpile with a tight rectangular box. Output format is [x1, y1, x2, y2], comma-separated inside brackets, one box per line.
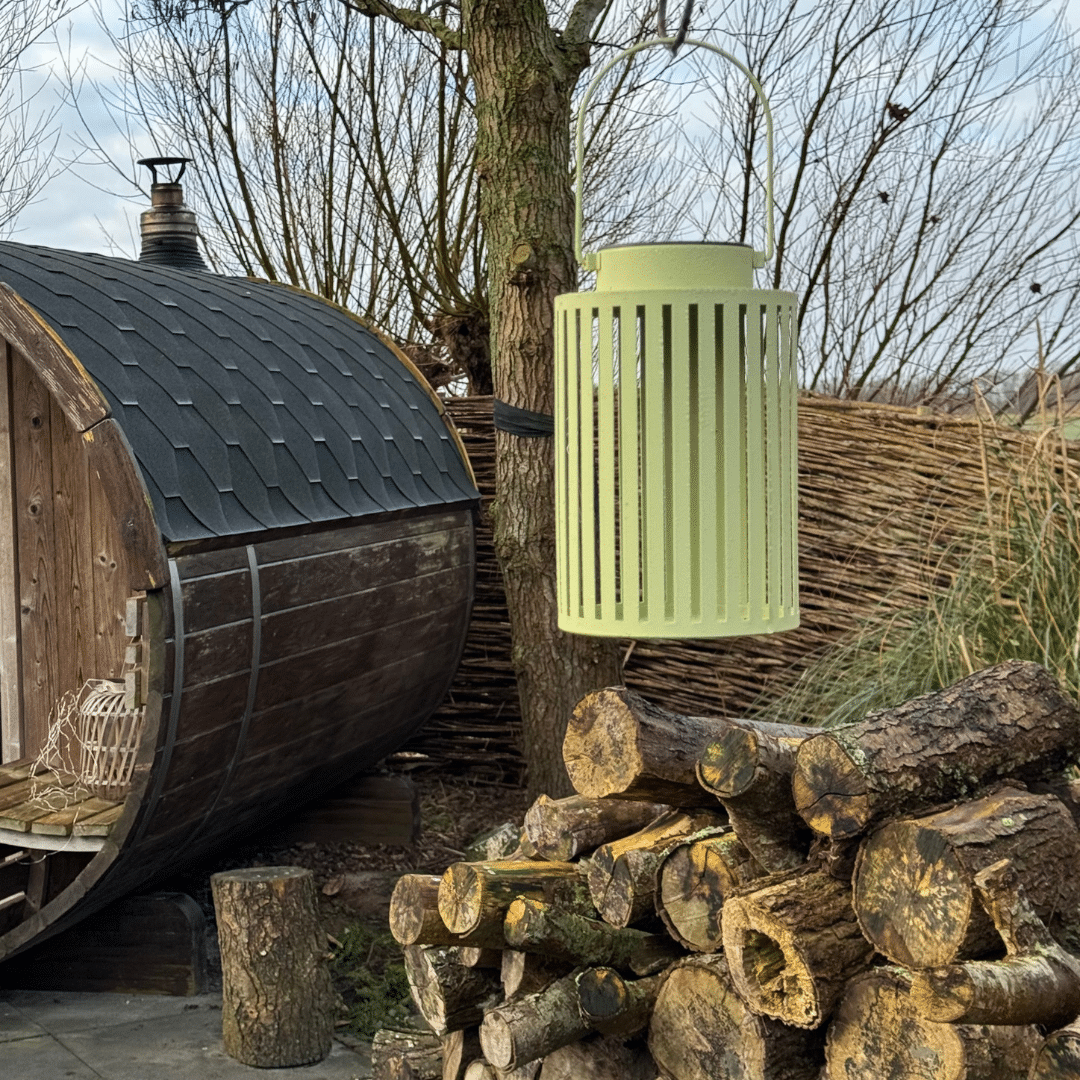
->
[503, 896, 679, 975]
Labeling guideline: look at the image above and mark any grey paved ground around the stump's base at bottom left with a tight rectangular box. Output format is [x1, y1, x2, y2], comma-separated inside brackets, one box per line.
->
[0, 989, 372, 1080]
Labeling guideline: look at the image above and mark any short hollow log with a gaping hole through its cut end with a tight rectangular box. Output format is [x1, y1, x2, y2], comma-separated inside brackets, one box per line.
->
[721, 870, 874, 1028]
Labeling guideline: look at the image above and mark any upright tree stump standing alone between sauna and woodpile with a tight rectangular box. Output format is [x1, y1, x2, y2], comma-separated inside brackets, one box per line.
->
[211, 866, 337, 1068]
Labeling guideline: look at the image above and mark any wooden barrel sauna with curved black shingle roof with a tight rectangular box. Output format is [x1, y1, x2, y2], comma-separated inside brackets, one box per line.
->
[0, 243, 477, 959]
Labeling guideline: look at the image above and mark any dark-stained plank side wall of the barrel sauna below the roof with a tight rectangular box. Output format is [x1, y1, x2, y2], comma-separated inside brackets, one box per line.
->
[136, 510, 473, 852]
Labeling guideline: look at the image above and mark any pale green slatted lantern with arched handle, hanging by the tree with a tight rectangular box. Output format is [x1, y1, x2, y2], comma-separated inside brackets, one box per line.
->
[555, 39, 799, 638]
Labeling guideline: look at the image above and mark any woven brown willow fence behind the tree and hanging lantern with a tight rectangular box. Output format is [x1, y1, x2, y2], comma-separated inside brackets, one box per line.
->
[406, 396, 1062, 782]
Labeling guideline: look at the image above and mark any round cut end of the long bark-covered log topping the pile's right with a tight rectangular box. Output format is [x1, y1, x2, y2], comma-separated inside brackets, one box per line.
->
[792, 733, 874, 840]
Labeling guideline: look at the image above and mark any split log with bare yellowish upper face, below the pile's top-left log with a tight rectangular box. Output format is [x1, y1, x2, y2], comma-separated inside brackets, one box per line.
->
[589, 810, 724, 927]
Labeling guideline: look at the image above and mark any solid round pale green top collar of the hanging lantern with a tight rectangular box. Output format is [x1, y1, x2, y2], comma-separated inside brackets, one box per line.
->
[595, 241, 754, 293]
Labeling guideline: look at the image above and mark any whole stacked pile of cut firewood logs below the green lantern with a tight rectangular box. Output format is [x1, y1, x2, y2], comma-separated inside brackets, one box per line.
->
[387, 661, 1080, 1080]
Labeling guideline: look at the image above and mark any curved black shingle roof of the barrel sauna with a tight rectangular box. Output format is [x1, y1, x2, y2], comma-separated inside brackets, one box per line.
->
[0, 243, 477, 541]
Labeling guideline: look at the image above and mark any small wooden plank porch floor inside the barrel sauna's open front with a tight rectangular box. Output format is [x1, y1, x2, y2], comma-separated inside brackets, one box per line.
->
[0, 760, 123, 851]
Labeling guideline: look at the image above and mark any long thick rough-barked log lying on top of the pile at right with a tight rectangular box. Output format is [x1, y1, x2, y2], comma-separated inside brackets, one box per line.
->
[792, 660, 1080, 839]
